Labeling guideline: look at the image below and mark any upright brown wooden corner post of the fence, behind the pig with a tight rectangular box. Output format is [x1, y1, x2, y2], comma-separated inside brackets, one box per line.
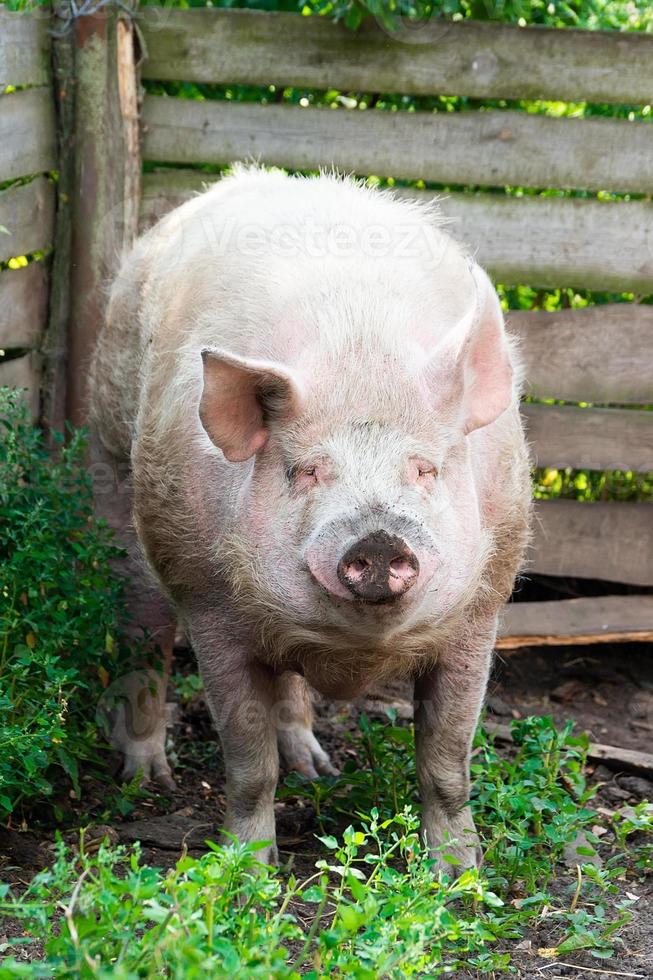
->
[66, 7, 141, 425]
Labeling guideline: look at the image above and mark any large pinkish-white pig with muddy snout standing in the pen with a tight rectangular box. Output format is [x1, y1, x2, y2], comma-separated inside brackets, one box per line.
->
[90, 166, 531, 870]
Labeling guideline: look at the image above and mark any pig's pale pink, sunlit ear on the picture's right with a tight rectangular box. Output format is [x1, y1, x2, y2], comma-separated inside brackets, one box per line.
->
[429, 264, 513, 434]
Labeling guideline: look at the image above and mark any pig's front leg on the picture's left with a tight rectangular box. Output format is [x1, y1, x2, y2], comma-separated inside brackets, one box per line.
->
[188, 615, 279, 864]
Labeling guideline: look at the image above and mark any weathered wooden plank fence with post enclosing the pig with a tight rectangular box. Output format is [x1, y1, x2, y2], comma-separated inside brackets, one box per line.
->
[0, 8, 653, 647]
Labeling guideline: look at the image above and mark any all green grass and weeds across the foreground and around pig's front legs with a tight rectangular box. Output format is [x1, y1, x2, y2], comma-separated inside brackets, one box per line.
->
[0, 718, 653, 980]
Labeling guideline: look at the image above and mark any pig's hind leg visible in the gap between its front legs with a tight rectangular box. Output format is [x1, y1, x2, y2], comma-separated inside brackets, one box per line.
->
[275, 671, 338, 779]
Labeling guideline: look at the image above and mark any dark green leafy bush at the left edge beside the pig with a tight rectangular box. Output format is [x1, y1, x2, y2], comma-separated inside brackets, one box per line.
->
[0, 388, 121, 818]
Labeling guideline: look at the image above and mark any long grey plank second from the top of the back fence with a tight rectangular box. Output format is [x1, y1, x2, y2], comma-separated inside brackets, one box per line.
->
[143, 96, 653, 193]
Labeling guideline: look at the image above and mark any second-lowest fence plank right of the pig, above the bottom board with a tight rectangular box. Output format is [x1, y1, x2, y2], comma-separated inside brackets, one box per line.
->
[527, 500, 653, 585]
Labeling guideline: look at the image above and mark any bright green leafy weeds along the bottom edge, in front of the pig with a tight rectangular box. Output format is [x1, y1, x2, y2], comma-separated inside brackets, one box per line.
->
[0, 810, 502, 980]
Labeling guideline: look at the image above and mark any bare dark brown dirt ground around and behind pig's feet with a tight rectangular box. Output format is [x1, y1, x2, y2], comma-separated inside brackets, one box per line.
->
[0, 644, 653, 980]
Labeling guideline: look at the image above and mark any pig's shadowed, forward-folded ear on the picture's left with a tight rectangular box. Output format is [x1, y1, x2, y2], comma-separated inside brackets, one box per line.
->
[199, 349, 304, 463]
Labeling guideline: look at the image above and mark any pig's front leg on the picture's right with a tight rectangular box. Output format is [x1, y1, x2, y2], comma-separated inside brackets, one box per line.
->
[415, 617, 496, 874]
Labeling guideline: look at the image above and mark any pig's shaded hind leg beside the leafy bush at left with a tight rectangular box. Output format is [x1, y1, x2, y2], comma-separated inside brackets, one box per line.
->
[91, 432, 177, 790]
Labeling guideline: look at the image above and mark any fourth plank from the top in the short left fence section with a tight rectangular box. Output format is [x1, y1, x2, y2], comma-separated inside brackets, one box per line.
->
[0, 262, 49, 350]
